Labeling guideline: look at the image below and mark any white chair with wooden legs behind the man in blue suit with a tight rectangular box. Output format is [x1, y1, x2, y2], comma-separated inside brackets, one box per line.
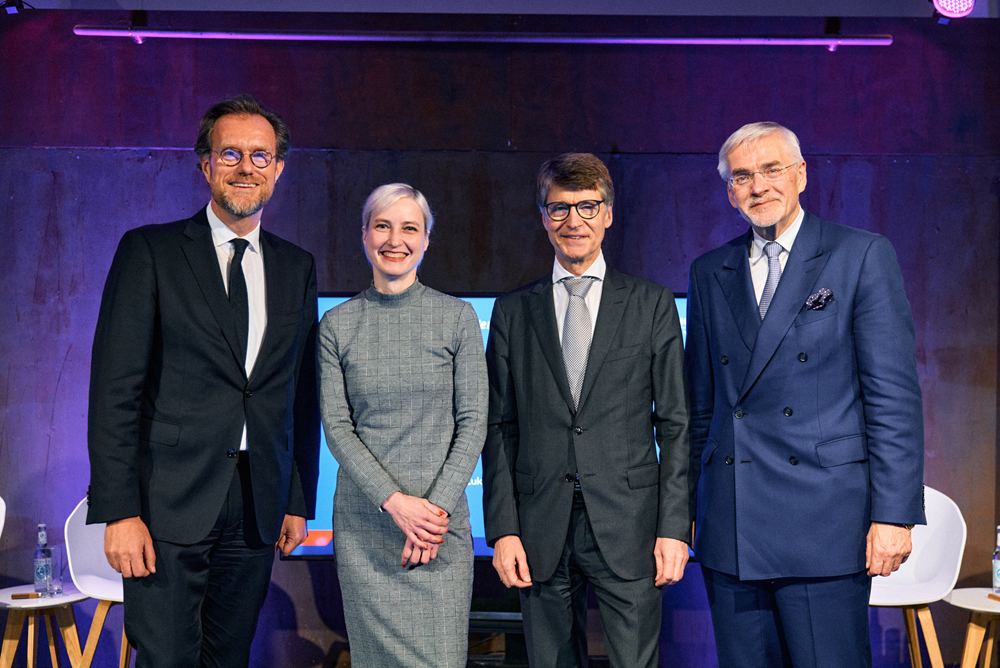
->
[868, 486, 967, 668]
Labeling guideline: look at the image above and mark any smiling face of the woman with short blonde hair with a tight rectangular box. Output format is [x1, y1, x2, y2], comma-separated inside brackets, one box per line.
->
[361, 197, 430, 294]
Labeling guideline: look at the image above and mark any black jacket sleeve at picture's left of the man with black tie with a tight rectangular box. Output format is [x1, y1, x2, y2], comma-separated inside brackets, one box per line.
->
[87, 230, 156, 523]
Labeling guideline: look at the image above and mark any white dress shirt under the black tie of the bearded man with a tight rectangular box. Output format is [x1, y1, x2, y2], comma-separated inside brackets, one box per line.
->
[207, 204, 267, 450]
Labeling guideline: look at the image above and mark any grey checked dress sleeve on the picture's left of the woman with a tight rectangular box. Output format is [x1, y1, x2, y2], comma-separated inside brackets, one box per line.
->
[316, 314, 400, 507]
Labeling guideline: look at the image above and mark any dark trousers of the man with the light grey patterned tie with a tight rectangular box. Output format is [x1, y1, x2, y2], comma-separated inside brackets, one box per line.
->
[521, 495, 663, 668]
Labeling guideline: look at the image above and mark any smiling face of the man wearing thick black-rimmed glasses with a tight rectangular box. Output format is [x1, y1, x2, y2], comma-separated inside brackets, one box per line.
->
[542, 186, 611, 276]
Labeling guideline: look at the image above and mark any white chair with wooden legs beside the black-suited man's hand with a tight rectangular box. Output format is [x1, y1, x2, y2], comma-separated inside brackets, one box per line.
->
[65, 499, 132, 668]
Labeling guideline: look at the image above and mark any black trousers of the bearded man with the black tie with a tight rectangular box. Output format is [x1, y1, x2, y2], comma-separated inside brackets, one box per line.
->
[125, 453, 274, 668]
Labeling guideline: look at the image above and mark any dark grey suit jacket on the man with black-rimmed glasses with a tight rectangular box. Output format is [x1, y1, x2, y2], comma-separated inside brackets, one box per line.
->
[483, 268, 692, 581]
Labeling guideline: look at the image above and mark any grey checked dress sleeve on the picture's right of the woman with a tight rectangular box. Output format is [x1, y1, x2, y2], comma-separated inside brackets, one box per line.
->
[427, 303, 489, 514]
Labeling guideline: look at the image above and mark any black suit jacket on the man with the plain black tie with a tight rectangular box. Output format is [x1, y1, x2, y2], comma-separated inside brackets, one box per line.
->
[87, 209, 319, 544]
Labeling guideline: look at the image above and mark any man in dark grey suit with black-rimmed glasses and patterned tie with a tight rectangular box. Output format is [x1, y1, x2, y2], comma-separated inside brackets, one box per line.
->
[483, 153, 692, 668]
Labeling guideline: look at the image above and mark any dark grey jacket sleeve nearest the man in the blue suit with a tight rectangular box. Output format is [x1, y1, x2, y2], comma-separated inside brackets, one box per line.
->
[651, 289, 693, 543]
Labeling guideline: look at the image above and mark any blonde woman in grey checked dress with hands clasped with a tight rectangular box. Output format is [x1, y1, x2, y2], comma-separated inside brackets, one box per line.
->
[318, 183, 488, 668]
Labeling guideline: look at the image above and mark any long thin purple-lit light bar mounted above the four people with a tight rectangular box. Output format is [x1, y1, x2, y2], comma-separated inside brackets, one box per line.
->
[73, 25, 892, 51]
